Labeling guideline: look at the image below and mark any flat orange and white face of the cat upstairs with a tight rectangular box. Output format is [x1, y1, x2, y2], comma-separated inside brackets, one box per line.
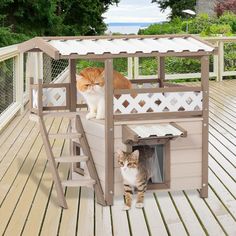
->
[76, 68, 105, 95]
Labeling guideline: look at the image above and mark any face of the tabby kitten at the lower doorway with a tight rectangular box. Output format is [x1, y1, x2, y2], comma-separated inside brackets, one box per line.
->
[117, 150, 139, 171]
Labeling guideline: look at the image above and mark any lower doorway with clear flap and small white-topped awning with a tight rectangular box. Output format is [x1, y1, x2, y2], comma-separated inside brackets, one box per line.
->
[122, 123, 187, 189]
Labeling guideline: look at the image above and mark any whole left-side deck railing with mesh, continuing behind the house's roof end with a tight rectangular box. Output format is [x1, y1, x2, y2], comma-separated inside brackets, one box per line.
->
[0, 48, 69, 132]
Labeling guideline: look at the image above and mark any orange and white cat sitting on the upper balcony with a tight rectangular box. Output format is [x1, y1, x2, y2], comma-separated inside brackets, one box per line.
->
[76, 67, 132, 119]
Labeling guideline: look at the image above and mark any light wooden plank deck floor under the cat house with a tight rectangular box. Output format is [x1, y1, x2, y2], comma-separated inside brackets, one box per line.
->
[0, 80, 236, 236]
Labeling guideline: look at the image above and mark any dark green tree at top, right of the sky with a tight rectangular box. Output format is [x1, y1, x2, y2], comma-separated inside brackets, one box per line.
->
[152, 0, 196, 19]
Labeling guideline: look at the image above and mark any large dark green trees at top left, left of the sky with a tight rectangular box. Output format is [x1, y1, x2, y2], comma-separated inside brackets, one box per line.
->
[0, 0, 119, 46]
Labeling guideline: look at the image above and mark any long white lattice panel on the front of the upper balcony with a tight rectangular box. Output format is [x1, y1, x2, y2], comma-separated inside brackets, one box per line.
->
[114, 92, 202, 114]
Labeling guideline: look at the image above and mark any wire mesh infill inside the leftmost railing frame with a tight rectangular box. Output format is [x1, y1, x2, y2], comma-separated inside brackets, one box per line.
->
[0, 57, 16, 115]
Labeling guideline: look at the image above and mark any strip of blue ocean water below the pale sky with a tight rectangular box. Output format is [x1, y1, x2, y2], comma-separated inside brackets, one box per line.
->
[107, 23, 156, 34]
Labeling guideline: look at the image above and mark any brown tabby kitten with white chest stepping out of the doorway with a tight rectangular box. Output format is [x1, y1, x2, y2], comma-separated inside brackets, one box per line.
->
[116, 146, 154, 210]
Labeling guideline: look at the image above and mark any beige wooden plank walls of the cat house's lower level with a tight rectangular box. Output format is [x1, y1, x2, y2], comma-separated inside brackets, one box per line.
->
[81, 111, 202, 195]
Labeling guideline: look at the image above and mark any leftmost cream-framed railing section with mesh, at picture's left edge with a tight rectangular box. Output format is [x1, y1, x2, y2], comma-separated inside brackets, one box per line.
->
[0, 45, 24, 130]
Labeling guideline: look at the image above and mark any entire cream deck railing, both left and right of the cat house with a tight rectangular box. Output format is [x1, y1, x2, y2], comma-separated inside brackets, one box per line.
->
[0, 37, 236, 131]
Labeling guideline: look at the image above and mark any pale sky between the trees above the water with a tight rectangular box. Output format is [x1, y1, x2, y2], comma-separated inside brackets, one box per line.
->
[103, 0, 170, 23]
